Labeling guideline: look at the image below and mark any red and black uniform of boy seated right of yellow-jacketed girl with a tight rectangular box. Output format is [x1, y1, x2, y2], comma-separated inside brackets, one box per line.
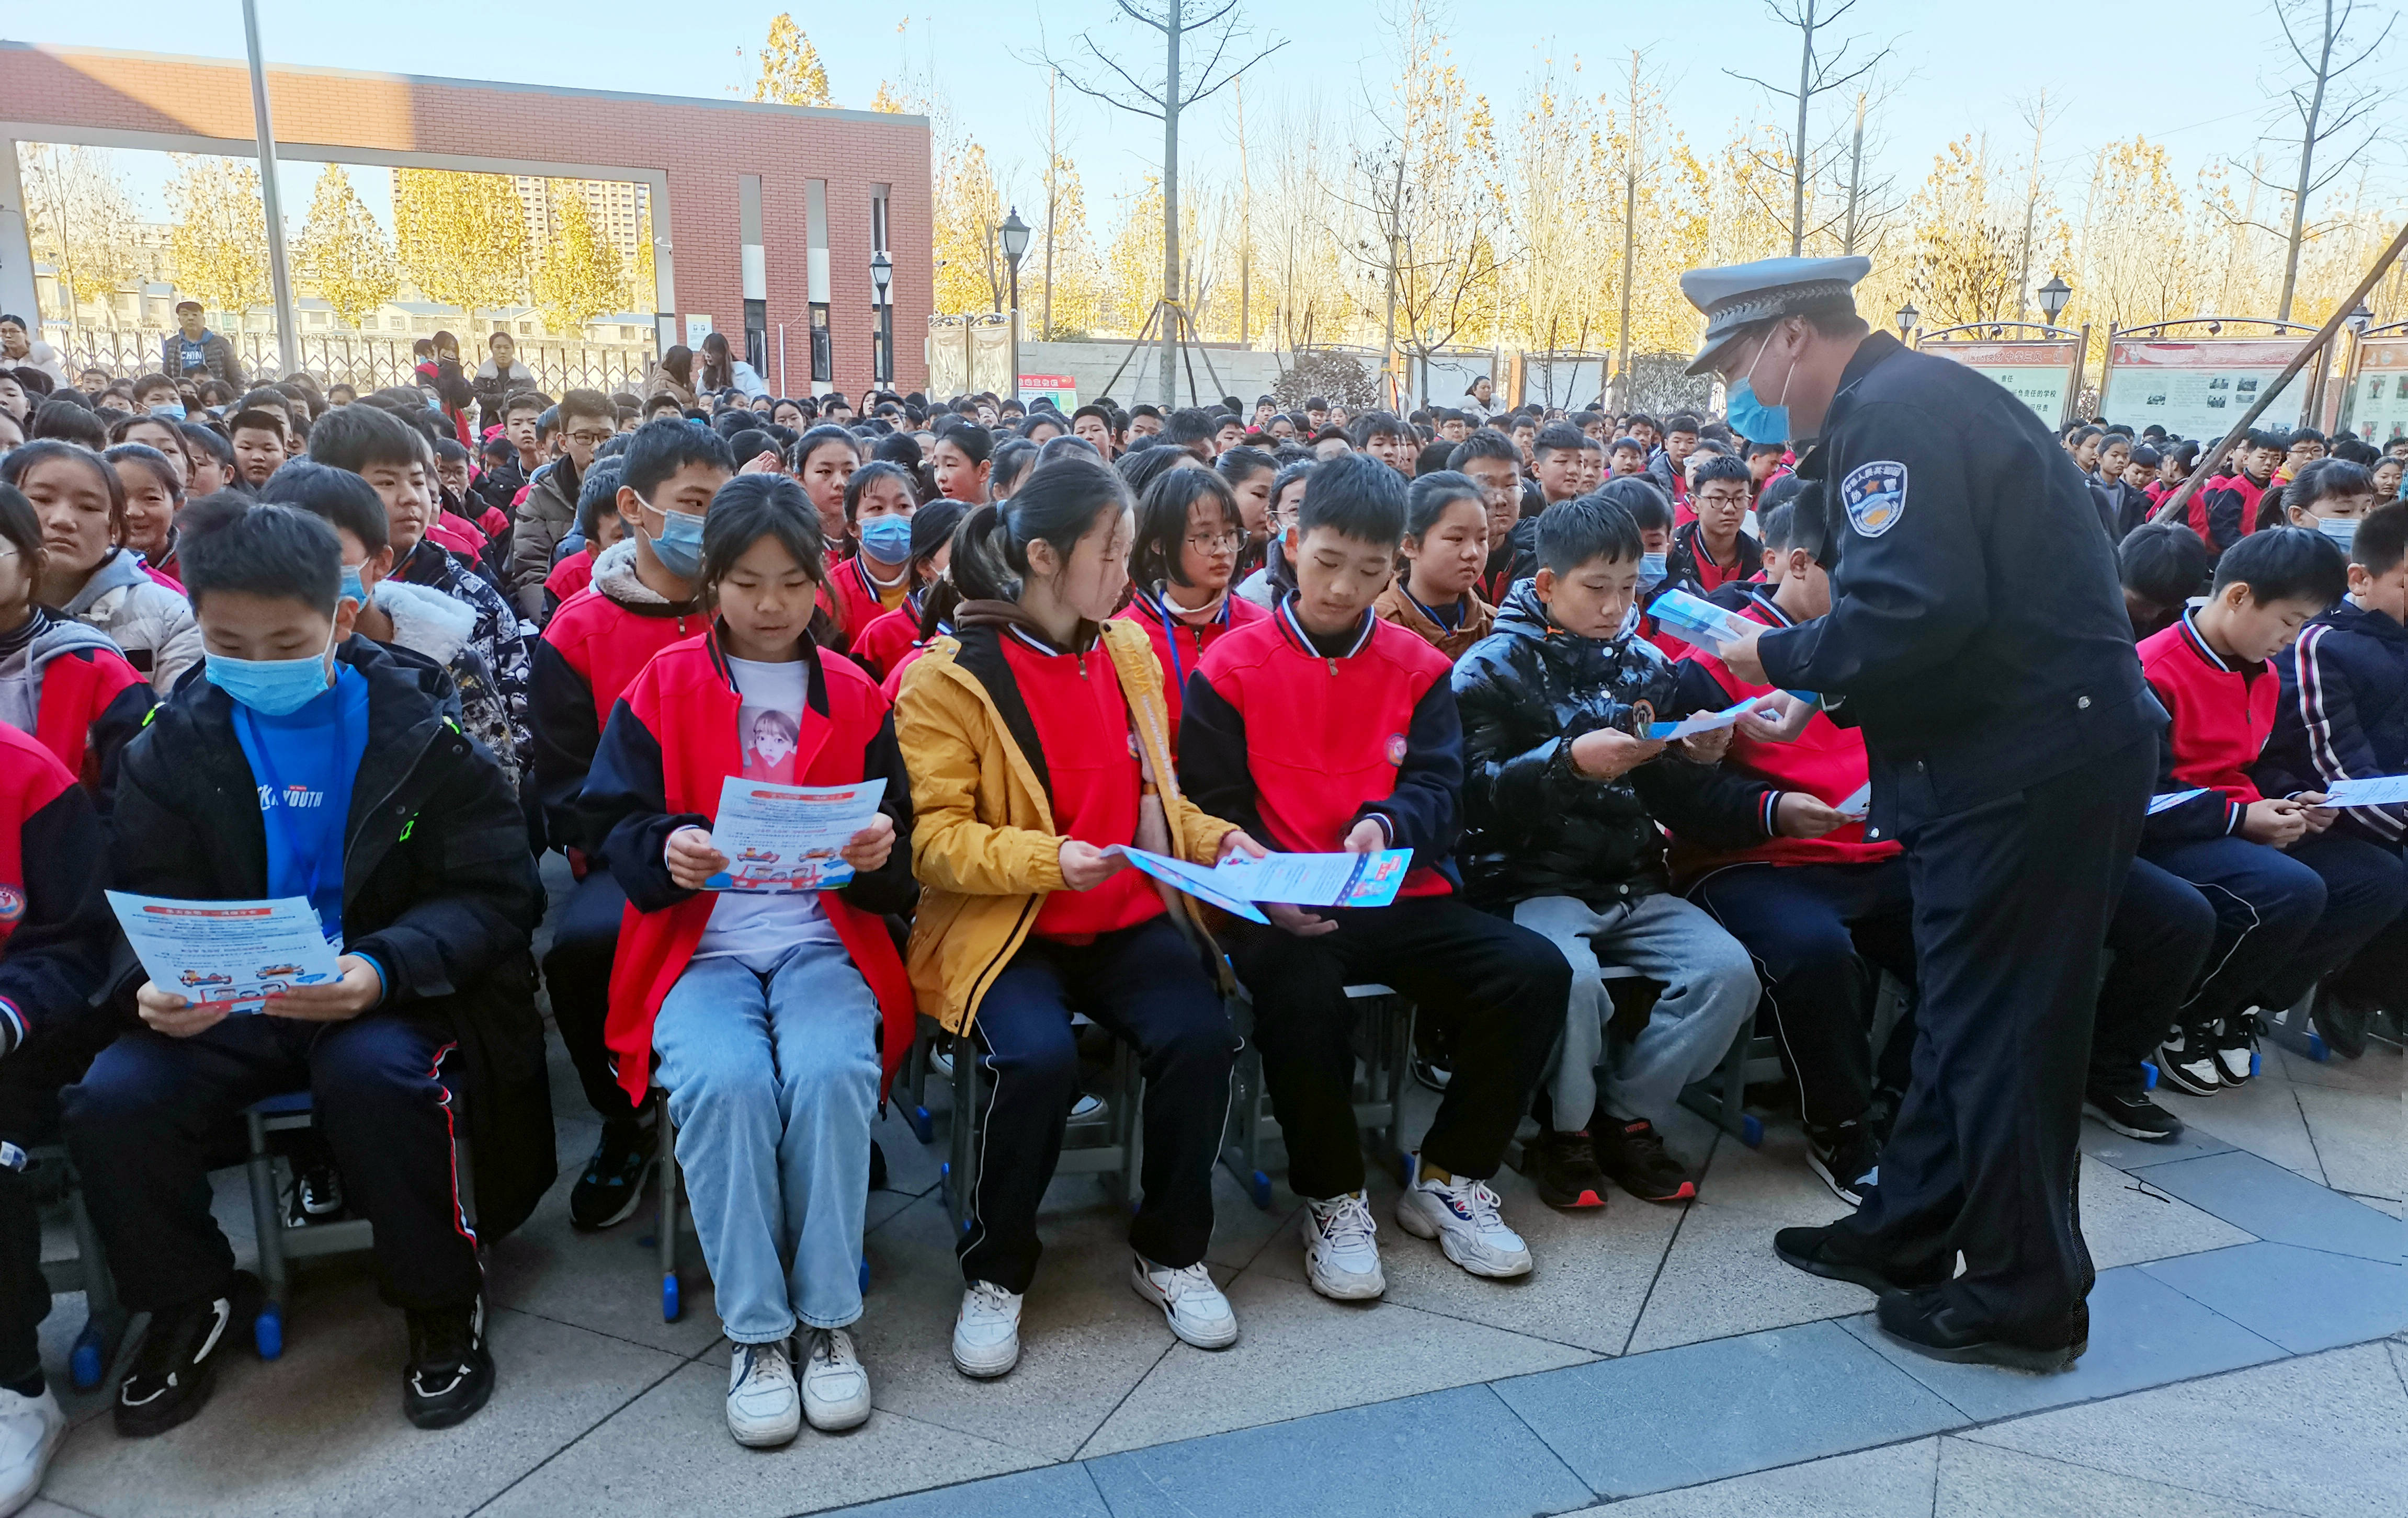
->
[1180, 597, 1572, 1198]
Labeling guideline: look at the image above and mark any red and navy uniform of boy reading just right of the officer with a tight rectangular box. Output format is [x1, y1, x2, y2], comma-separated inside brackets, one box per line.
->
[2141, 611, 2408, 1049]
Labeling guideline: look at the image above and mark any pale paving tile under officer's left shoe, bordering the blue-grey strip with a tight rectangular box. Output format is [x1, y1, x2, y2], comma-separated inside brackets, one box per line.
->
[1614, 1123, 1873, 1354]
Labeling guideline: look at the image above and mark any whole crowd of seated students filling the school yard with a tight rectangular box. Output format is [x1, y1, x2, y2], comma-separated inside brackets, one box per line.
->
[0, 363, 2408, 1511]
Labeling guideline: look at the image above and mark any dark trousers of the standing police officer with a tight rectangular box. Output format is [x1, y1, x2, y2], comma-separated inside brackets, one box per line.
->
[1839, 741, 2155, 1342]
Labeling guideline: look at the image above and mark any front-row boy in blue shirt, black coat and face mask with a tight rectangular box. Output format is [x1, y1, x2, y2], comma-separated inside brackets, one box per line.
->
[65, 500, 554, 1436]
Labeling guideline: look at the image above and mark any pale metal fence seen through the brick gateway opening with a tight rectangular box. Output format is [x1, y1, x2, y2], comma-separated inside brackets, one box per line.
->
[43, 325, 653, 395]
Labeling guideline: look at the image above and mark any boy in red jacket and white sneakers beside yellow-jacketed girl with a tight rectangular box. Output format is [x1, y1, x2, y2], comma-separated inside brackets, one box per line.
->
[1180, 452, 1580, 1299]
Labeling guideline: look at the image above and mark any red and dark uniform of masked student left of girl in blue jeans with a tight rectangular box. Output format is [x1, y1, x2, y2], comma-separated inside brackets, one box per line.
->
[527, 555, 708, 1123]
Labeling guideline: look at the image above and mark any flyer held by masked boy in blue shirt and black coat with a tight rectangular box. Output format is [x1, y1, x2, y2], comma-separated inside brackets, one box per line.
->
[108, 890, 342, 1010]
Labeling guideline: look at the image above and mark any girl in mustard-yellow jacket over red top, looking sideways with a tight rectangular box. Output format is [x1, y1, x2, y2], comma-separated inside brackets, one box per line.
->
[896, 457, 1262, 1376]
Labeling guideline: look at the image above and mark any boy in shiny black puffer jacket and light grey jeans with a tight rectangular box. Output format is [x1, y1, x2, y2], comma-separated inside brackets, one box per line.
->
[1455, 496, 1837, 1208]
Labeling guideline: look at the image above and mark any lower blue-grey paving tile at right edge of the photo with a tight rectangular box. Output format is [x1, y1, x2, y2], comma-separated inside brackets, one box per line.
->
[2143, 1244, 2408, 1354]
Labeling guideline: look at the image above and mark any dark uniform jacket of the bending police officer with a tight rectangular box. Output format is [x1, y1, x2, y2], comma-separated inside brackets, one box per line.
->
[1760, 332, 2165, 837]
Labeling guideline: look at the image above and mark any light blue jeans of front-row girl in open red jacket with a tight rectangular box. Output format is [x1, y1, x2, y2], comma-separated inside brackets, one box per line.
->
[653, 941, 879, 1345]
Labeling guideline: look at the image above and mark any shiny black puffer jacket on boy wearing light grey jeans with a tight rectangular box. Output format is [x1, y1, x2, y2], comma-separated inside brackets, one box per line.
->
[1455, 580, 1767, 907]
